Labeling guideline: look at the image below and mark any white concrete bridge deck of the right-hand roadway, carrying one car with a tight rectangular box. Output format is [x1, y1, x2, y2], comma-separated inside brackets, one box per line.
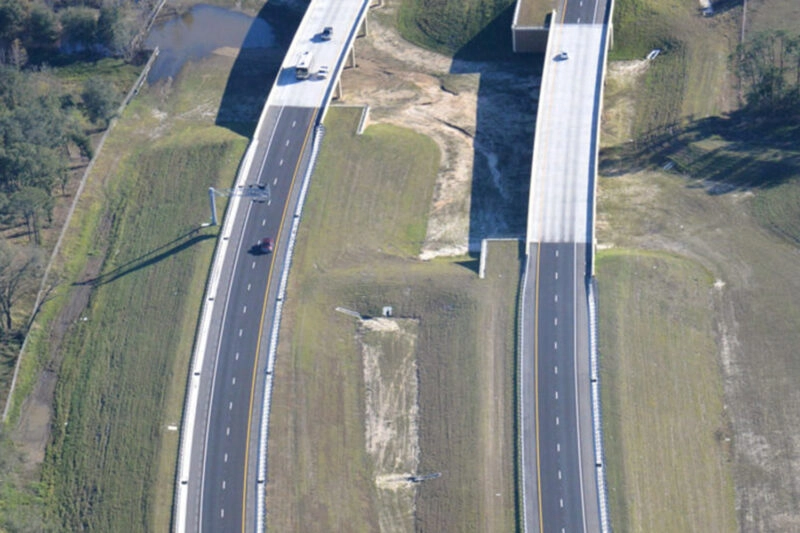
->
[527, 24, 605, 243]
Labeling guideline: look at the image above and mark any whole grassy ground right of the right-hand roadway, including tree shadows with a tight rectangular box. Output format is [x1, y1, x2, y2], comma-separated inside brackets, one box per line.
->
[598, 0, 800, 531]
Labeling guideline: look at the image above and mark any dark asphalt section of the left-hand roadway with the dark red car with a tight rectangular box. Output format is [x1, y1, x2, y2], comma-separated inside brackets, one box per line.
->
[187, 107, 317, 533]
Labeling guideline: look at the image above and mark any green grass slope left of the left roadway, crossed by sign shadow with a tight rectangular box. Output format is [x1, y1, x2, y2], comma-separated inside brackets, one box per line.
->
[14, 53, 247, 531]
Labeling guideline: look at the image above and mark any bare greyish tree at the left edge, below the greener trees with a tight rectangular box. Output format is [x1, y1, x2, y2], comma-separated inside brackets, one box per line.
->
[0, 238, 42, 332]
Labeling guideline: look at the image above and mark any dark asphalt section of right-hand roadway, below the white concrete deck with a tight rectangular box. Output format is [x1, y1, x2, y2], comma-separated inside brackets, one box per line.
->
[522, 243, 599, 533]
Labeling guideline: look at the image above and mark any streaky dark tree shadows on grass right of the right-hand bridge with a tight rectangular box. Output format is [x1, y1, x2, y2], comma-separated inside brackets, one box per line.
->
[599, 109, 800, 194]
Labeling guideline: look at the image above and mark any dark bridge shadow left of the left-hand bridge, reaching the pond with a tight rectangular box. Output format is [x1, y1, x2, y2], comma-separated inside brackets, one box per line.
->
[216, 2, 304, 138]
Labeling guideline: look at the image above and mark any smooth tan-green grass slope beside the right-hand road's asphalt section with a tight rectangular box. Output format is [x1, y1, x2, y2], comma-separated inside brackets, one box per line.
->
[597, 251, 736, 533]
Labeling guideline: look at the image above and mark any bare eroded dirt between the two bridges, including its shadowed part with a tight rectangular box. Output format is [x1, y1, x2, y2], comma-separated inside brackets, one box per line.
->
[342, 0, 540, 259]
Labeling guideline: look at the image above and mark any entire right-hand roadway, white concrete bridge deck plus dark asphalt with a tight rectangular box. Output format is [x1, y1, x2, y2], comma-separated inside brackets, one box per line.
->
[518, 0, 613, 533]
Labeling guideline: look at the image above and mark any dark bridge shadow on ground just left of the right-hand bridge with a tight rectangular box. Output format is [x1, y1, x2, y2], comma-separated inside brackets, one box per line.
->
[450, 4, 542, 251]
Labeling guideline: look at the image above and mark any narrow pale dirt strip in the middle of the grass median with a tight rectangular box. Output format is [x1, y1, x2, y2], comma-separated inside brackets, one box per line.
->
[358, 318, 420, 533]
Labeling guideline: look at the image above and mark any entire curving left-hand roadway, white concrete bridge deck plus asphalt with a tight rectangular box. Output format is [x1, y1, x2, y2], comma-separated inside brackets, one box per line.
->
[173, 0, 374, 533]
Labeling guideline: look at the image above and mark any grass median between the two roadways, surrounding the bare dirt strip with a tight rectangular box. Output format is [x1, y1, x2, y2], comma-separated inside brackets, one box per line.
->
[267, 108, 520, 531]
